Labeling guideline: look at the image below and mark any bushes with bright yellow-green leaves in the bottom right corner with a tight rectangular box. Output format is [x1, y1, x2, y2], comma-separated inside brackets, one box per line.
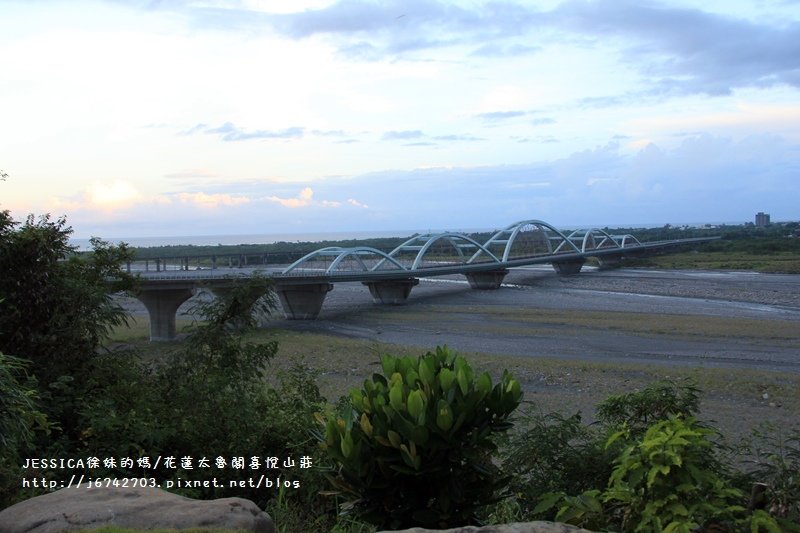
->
[500, 382, 800, 533]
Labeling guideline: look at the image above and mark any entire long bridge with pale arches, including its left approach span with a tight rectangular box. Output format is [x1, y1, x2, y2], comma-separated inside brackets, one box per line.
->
[129, 220, 718, 341]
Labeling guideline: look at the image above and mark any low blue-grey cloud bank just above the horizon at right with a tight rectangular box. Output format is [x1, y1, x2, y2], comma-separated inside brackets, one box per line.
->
[329, 135, 800, 229]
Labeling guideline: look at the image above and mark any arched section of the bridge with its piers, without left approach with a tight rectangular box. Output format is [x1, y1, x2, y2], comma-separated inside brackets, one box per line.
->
[273, 219, 711, 319]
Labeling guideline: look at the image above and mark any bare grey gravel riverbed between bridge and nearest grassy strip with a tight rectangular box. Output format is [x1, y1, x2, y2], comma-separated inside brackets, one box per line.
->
[279, 268, 800, 373]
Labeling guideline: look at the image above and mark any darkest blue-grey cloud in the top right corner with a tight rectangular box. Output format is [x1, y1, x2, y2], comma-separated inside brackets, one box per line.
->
[551, 0, 800, 95]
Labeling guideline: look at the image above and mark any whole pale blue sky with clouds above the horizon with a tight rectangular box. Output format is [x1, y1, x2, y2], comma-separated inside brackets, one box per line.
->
[0, 0, 800, 239]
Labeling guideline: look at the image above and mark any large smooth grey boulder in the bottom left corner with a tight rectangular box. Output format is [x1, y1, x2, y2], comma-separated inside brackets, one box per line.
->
[0, 487, 275, 533]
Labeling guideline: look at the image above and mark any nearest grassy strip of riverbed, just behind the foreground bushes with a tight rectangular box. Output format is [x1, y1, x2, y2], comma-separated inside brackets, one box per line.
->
[270, 330, 800, 441]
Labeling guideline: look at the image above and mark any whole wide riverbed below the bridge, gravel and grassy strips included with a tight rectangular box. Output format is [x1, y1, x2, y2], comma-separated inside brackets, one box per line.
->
[275, 268, 800, 436]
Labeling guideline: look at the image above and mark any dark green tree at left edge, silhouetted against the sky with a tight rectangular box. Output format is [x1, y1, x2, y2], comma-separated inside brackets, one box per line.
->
[0, 211, 133, 386]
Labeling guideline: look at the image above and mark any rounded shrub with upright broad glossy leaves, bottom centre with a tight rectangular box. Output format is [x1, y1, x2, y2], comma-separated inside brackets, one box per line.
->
[318, 347, 522, 529]
